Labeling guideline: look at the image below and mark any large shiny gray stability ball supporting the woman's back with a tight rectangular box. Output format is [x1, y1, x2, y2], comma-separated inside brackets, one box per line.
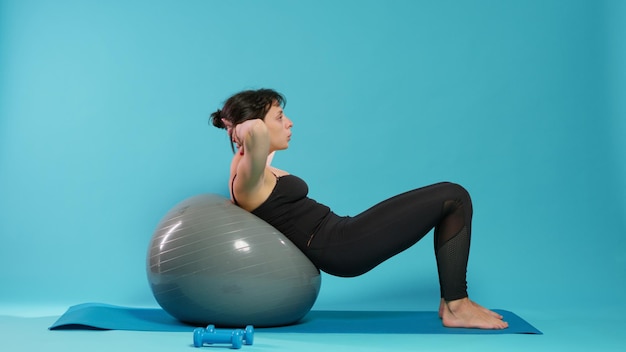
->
[147, 194, 321, 327]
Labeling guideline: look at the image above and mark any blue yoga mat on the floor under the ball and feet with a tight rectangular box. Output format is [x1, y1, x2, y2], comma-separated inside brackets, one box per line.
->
[50, 303, 542, 334]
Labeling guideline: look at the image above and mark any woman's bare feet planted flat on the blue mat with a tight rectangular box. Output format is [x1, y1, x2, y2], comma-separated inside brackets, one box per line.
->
[439, 297, 509, 329]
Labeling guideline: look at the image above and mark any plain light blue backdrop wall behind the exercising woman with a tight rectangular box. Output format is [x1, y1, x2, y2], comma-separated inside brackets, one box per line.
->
[0, 0, 626, 316]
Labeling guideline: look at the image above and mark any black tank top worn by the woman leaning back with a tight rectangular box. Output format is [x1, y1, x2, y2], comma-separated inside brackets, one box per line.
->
[233, 175, 331, 245]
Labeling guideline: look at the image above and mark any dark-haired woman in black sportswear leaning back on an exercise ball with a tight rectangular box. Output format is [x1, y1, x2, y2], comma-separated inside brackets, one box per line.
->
[211, 89, 508, 329]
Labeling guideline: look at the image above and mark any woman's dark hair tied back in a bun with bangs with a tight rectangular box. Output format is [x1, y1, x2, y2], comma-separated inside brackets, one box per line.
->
[211, 88, 287, 152]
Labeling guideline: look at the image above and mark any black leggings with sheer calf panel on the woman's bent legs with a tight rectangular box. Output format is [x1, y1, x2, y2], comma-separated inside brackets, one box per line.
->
[304, 182, 472, 301]
